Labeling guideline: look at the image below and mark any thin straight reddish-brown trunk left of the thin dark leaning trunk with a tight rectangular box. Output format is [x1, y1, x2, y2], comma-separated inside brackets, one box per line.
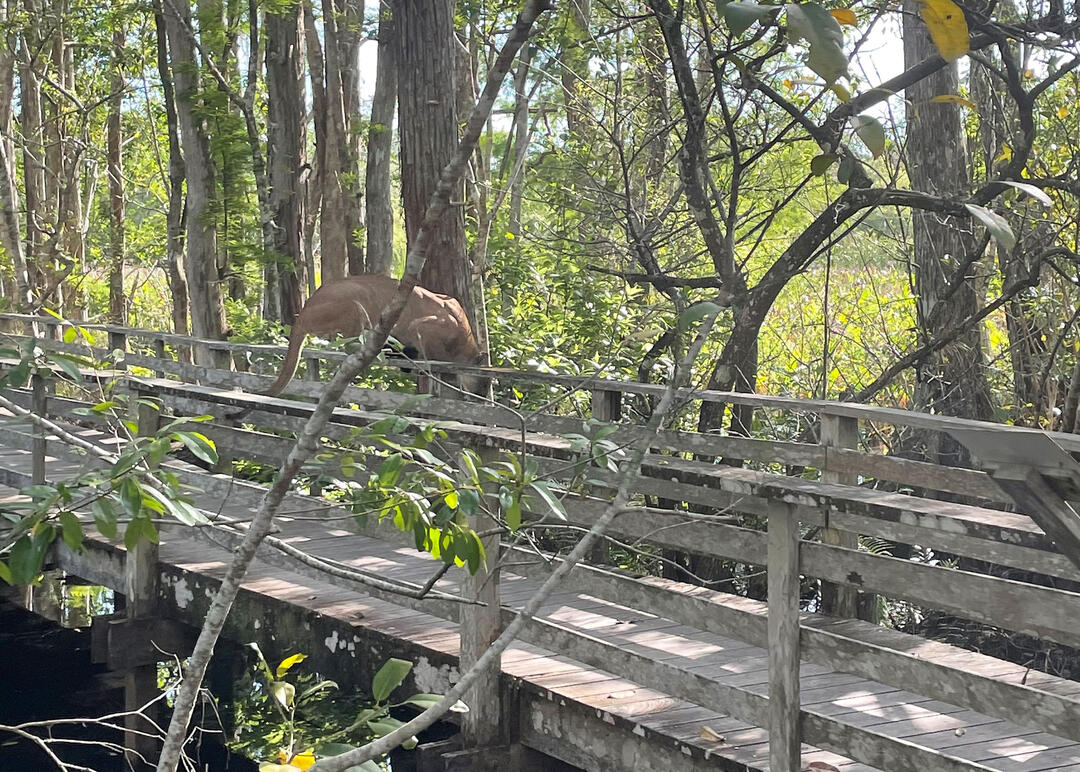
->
[106, 22, 126, 324]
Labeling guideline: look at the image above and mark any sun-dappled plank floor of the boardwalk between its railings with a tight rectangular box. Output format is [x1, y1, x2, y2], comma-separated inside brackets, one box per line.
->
[0, 430, 1080, 772]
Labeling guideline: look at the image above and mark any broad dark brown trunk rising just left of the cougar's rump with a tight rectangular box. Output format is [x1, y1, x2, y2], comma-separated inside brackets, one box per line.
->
[266, 2, 305, 323]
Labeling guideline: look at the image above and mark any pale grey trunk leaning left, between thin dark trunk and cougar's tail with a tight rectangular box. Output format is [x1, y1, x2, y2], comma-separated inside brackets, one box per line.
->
[164, 3, 225, 366]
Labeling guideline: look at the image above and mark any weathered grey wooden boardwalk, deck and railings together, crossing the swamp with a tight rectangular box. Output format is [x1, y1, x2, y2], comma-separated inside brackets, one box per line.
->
[0, 317, 1080, 772]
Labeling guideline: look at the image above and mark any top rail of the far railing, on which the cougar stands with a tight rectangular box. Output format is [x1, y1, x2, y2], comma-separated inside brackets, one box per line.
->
[0, 313, 1080, 452]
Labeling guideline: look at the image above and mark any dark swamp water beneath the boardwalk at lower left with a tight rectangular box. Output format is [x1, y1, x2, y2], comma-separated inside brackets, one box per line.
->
[0, 578, 456, 772]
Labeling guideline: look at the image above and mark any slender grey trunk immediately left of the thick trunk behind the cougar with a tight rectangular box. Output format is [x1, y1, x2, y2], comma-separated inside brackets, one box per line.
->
[365, 0, 397, 276]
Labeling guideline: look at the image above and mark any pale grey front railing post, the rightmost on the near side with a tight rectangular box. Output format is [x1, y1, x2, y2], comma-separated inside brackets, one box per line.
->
[768, 502, 802, 772]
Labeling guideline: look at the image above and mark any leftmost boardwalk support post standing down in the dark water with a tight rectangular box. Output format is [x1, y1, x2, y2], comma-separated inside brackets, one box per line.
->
[123, 402, 161, 770]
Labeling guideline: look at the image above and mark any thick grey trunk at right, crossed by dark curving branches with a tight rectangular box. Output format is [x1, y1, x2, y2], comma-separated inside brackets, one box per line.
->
[903, 0, 994, 464]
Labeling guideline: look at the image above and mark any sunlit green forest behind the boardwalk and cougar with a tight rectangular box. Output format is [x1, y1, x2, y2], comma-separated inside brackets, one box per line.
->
[0, 0, 1080, 464]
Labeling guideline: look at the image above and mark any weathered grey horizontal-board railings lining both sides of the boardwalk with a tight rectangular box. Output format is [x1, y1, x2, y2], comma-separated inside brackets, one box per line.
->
[3, 315, 1080, 772]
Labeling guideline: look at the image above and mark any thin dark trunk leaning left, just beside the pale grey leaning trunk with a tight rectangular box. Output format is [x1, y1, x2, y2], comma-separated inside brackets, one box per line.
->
[153, 0, 190, 347]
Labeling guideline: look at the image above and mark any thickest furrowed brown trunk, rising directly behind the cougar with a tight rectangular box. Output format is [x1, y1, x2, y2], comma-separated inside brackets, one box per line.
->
[394, 0, 475, 322]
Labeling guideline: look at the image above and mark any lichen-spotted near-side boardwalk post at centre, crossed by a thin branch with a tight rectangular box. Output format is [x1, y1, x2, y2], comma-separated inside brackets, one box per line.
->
[460, 448, 505, 747]
